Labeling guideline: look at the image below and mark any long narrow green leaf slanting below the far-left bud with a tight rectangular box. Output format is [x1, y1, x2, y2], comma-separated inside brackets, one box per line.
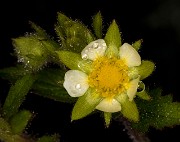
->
[3, 74, 36, 119]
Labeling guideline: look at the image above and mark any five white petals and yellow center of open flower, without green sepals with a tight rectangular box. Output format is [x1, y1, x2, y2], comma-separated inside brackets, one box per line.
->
[63, 39, 141, 112]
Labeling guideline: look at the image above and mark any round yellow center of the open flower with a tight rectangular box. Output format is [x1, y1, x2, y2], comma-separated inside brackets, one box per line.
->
[88, 57, 129, 98]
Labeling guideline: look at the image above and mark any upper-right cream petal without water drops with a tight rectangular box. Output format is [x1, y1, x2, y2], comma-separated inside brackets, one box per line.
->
[120, 43, 141, 67]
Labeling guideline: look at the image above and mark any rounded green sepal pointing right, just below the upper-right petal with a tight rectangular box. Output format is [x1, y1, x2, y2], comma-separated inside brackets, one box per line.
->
[136, 60, 155, 80]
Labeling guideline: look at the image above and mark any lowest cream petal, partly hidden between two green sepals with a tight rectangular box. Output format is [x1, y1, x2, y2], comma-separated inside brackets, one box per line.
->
[96, 98, 121, 112]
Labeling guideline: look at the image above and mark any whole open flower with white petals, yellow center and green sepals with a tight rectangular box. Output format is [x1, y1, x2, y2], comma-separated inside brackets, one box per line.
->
[57, 21, 154, 123]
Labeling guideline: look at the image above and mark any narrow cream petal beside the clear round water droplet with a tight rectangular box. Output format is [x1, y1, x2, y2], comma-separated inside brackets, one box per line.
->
[127, 77, 139, 101]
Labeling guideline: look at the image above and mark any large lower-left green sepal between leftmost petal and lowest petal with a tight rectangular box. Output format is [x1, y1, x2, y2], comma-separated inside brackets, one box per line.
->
[71, 88, 102, 120]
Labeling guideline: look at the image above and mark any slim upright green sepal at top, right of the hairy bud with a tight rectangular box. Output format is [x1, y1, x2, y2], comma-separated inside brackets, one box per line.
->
[93, 11, 103, 39]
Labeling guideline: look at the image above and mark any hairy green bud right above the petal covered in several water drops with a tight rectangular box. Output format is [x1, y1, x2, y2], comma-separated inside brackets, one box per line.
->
[55, 13, 95, 53]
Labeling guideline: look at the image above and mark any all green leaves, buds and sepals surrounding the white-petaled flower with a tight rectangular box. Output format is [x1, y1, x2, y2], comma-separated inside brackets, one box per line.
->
[0, 12, 180, 142]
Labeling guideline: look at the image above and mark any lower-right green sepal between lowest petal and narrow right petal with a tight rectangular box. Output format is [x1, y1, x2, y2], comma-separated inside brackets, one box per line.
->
[116, 94, 139, 122]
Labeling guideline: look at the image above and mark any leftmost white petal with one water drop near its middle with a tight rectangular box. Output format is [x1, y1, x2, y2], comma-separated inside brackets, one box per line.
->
[63, 70, 89, 97]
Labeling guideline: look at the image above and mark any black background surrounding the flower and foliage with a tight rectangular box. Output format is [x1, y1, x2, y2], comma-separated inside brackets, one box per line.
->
[0, 0, 180, 142]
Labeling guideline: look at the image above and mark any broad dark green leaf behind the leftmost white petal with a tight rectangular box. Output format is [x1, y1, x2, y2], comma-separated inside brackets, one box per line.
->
[31, 68, 76, 103]
